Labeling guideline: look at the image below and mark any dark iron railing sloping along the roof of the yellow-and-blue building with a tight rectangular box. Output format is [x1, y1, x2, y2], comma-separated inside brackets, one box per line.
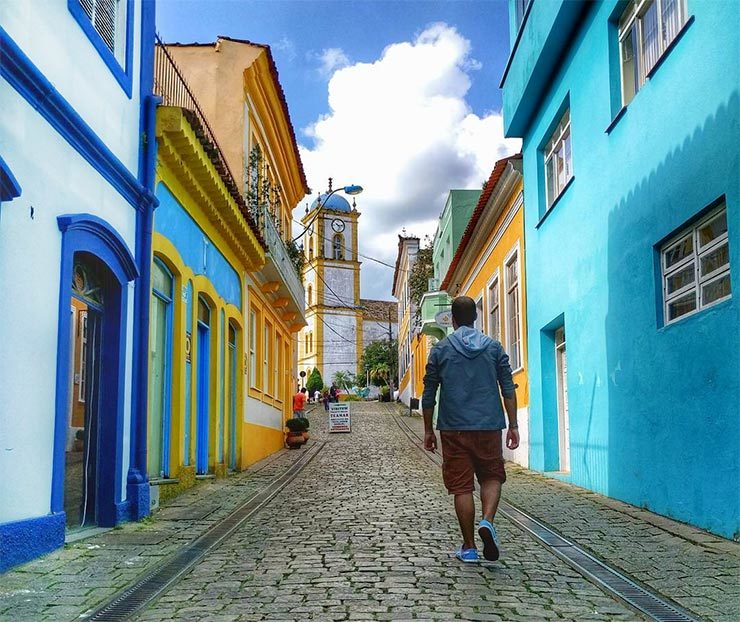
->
[154, 35, 264, 245]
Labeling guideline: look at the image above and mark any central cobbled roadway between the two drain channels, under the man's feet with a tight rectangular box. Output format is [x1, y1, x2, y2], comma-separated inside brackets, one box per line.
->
[137, 404, 640, 622]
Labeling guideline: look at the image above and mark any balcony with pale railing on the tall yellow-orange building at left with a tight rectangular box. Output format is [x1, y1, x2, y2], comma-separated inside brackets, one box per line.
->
[255, 207, 306, 325]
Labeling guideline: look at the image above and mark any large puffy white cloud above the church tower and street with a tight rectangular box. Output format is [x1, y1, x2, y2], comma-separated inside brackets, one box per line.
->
[294, 23, 519, 298]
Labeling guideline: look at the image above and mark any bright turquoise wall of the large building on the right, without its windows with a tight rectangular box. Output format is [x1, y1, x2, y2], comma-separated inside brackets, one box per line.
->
[504, 0, 740, 537]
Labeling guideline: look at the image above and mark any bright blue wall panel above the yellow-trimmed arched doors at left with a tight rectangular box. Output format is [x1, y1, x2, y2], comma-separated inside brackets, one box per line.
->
[154, 183, 242, 309]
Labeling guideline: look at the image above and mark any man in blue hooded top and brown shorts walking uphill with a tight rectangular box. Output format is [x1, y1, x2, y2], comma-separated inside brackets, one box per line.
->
[421, 296, 519, 562]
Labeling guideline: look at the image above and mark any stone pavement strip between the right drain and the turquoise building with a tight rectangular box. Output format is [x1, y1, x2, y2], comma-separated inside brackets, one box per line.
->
[404, 410, 740, 622]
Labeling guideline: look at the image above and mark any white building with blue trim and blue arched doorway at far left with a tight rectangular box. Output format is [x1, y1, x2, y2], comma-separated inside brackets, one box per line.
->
[0, 0, 156, 571]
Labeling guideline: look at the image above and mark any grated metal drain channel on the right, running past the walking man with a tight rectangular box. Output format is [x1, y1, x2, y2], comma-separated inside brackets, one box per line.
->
[394, 413, 698, 622]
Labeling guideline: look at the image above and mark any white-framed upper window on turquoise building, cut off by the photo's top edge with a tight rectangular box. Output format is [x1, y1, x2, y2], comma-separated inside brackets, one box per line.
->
[619, 0, 686, 106]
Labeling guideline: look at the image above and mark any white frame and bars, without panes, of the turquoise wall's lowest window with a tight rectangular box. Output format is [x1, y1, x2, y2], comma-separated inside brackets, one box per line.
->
[660, 201, 732, 325]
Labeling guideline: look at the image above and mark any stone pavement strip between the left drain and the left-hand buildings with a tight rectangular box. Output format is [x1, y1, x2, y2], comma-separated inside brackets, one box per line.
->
[0, 451, 312, 622]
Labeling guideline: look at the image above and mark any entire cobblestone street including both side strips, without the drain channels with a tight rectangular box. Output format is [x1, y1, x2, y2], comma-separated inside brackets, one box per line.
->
[0, 403, 740, 622]
